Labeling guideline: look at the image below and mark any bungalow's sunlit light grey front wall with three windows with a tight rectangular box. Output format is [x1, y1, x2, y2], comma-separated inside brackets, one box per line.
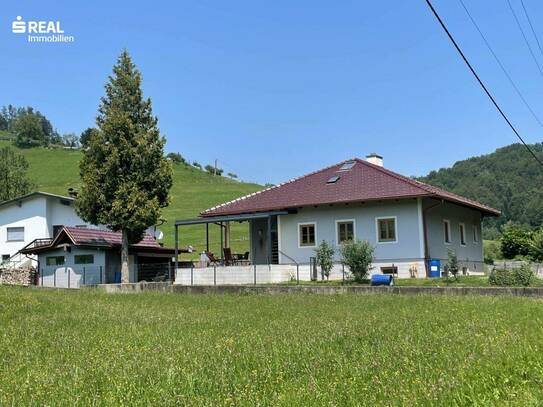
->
[278, 199, 424, 263]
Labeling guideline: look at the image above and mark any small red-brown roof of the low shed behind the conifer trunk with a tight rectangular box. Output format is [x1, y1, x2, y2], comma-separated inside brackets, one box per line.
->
[21, 226, 181, 253]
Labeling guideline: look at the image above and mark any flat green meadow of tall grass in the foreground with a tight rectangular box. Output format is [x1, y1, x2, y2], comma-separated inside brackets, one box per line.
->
[0, 287, 543, 406]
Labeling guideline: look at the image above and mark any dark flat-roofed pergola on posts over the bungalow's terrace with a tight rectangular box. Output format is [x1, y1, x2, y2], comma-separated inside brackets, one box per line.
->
[175, 211, 289, 270]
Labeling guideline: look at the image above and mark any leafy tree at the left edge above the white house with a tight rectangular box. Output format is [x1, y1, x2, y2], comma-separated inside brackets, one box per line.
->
[0, 147, 33, 202]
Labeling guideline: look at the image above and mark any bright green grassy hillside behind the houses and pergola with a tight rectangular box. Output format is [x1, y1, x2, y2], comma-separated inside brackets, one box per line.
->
[0, 141, 263, 253]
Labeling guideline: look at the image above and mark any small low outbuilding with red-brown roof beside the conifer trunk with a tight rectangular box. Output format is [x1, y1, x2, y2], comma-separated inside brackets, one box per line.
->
[21, 226, 178, 288]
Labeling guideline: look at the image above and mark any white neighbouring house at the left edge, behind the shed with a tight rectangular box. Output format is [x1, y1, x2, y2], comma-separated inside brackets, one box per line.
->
[0, 192, 89, 266]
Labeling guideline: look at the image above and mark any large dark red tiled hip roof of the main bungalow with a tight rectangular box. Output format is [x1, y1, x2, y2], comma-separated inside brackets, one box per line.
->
[200, 158, 500, 217]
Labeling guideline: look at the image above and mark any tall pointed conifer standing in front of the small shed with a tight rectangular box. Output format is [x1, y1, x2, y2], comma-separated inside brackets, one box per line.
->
[76, 50, 172, 283]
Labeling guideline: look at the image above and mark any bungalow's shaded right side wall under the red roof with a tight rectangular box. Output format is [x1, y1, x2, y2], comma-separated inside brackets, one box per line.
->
[423, 199, 483, 262]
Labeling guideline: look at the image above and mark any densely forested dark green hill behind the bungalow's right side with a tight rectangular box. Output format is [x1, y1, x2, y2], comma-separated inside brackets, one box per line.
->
[419, 143, 543, 237]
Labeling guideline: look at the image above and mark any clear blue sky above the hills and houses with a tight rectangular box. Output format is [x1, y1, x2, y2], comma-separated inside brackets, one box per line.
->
[0, 0, 543, 184]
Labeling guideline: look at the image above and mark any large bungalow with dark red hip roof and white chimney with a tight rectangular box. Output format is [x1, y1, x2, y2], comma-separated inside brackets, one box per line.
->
[176, 154, 500, 277]
